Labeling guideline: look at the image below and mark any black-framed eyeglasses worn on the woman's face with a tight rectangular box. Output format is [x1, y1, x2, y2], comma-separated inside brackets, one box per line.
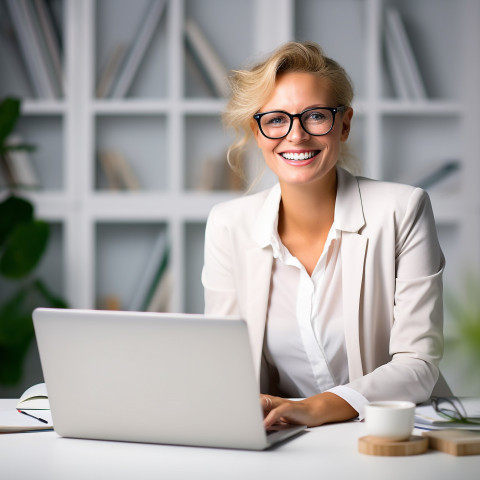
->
[253, 106, 346, 140]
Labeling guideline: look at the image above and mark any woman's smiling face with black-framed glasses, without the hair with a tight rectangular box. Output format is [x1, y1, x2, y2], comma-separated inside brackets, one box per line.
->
[249, 72, 353, 192]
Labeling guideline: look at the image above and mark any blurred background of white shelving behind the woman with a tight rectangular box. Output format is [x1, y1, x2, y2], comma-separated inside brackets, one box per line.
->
[0, 0, 480, 397]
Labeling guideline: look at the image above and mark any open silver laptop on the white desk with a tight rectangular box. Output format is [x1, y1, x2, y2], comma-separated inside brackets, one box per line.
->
[33, 308, 305, 450]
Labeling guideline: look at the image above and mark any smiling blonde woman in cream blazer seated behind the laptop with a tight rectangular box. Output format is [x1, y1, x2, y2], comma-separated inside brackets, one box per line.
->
[202, 42, 444, 427]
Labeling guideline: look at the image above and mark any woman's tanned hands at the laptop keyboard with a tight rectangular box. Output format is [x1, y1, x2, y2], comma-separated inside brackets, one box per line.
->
[260, 392, 358, 428]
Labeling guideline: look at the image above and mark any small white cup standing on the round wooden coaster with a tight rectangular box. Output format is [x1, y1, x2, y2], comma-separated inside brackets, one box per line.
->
[365, 401, 415, 442]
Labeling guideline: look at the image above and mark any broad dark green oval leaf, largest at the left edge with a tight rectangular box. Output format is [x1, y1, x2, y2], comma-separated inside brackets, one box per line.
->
[0, 220, 50, 279]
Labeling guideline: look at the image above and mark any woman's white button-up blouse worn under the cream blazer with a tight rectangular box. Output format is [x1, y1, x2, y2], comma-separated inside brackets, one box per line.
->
[264, 191, 368, 417]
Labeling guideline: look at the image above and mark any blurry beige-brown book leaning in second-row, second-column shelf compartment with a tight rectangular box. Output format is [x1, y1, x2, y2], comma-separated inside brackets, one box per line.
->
[99, 149, 140, 190]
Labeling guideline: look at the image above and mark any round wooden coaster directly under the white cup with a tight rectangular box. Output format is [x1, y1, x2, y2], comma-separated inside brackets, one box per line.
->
[358, 435, 428, 457]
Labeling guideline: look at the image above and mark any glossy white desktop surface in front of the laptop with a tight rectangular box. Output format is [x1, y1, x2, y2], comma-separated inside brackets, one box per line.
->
[0, 400, 480, 480]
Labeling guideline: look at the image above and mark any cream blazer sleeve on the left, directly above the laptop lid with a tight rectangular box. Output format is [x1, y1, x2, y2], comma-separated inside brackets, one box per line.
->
[202, 205, 240, 315]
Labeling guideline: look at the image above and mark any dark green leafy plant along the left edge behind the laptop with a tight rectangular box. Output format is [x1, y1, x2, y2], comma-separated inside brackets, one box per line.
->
[0, 97, 67, 385]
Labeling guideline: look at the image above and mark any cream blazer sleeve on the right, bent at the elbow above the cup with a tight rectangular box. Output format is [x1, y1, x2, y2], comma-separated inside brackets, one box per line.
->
[348, 189, 445, 403]
